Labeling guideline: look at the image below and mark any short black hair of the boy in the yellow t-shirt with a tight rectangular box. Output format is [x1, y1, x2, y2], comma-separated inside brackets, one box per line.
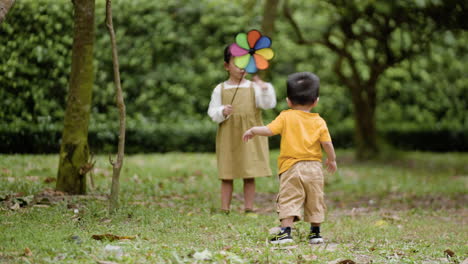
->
[286, 72, 320, 105]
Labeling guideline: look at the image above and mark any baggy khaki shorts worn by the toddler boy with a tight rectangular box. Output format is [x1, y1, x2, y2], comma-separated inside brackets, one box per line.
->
[277, 161, 327, 223]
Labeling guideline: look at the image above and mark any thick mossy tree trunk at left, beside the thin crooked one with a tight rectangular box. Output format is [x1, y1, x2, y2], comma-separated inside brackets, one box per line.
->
[57, 0, 94, 194]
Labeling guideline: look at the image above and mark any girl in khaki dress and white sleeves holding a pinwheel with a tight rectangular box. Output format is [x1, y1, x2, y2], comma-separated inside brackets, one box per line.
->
[208, 46, 276, 213]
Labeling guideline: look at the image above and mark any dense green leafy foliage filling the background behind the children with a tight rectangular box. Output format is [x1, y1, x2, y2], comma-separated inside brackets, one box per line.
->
[0, 0, 468, 152]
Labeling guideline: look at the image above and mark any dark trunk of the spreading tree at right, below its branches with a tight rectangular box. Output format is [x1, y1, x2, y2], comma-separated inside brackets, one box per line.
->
[349, 86, 379, 160]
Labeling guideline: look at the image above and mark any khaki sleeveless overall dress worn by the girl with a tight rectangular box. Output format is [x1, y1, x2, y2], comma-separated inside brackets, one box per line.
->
[216, 83, 272, 180]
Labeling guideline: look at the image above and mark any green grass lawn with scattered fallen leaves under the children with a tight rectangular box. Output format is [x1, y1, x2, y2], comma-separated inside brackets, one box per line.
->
[0, 150, 468, 264]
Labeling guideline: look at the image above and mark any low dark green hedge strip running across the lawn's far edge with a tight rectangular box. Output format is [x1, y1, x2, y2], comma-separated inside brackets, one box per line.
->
[0, 122, 468, 154]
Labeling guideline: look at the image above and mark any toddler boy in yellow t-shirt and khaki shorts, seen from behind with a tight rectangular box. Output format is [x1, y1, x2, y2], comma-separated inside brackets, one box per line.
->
[243, 72, 337, 244]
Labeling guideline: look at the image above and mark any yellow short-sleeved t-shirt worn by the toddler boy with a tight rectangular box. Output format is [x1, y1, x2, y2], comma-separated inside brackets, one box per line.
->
[267, 109, 331, 174]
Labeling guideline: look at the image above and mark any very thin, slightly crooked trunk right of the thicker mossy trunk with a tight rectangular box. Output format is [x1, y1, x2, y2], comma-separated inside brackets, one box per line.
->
[106, 0, 125, 213]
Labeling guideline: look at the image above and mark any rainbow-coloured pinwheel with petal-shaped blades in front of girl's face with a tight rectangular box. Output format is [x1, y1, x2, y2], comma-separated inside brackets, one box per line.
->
[229, 29, 274, 73]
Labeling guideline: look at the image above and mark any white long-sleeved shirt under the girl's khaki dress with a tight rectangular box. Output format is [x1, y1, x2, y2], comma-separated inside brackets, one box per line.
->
[208, 80, 276, 123]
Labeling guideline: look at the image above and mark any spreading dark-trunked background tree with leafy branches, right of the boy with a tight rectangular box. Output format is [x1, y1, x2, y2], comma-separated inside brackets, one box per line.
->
[283, 0, 466, 159]
